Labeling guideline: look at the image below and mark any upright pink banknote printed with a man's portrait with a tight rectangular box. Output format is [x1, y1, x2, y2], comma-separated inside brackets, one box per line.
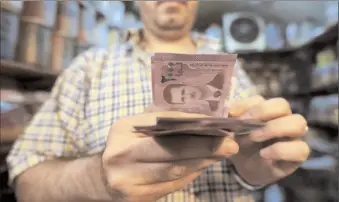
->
[151, 53, 237, 117]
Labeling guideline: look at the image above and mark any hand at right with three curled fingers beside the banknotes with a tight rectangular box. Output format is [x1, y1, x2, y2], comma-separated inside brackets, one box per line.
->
[230, 96, 310, 186]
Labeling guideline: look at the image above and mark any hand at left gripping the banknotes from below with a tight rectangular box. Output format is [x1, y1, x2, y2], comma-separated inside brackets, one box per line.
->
[102, 112, 239, 202]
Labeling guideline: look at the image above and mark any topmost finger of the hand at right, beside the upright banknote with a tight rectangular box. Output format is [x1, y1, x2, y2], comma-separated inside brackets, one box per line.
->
[242, 98, 292, 121]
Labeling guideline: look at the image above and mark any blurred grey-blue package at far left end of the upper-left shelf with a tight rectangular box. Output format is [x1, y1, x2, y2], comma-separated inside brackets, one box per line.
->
[0, 6, 20, 60]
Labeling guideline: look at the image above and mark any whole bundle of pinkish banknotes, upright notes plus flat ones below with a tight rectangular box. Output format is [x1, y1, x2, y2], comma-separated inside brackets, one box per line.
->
[135, 53, 264, 136]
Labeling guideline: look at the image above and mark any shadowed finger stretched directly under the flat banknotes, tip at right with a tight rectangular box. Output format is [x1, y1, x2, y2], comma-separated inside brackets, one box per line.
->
[131, 135, 239, 163]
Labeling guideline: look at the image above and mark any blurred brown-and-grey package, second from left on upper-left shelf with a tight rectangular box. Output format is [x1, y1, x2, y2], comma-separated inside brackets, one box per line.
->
[16, 18, 53, 72]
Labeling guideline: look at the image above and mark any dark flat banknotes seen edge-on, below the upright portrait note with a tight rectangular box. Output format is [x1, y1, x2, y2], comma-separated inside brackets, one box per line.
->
[134, 117, 265, 136]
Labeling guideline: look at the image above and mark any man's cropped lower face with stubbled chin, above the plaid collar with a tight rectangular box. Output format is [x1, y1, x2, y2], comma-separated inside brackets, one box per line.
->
[139, 0, 197, 38]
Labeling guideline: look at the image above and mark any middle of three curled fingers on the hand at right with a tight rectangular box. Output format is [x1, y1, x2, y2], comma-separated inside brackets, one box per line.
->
[250, 114, 307, 142]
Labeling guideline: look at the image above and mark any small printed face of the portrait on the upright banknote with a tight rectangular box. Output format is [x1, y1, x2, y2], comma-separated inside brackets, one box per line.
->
[171, 86, 203, 103]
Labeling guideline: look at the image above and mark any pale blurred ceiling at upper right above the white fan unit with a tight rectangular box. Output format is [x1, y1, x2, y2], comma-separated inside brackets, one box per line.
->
[197, 0, 326, 29]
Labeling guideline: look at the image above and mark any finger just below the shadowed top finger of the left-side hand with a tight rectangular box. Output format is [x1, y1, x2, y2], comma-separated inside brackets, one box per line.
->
[133, 159, 221, 185]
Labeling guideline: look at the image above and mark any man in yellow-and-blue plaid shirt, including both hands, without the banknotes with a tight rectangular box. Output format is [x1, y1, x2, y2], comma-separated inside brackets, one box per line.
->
[7, 1, 309, 202]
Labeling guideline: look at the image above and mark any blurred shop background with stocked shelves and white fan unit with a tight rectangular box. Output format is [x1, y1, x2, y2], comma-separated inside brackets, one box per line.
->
[0, 0, 338, 202]
